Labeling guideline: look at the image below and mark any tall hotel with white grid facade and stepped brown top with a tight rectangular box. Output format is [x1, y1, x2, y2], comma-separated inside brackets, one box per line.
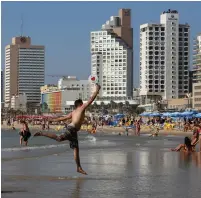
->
[91, 9, 133, 99]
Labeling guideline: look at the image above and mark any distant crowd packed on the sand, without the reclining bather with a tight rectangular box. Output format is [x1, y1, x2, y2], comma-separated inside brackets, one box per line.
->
[2, 114, 201, 135]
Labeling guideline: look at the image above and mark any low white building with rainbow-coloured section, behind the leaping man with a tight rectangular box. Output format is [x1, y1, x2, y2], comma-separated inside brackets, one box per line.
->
[41, 76, 91, 113]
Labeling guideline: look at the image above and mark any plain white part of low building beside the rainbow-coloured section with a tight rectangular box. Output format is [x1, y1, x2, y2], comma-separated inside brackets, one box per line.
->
[58, 76, 91, 100]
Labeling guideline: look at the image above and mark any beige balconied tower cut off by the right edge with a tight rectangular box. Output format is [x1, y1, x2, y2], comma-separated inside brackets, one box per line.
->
[193, 34, 201, 110]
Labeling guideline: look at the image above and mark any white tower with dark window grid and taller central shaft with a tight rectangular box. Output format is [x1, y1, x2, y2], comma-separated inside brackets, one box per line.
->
[140, 10, 190, 103]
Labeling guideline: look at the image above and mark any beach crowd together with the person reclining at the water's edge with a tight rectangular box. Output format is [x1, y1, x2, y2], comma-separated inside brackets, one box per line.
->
[1, 114, 201, 151]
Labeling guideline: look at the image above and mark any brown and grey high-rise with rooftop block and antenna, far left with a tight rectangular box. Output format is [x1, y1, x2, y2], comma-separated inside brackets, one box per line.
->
[4, 36, 45, 106]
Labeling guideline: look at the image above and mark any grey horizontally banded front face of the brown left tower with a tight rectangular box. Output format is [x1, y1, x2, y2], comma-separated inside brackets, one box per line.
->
[18, 48, 45, 102]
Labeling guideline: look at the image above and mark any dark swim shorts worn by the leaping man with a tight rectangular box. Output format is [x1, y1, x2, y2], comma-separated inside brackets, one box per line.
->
[62, 125, 78, 149]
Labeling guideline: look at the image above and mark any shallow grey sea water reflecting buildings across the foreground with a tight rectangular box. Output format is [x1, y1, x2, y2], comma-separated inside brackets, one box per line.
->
[1, 131, 201, 198]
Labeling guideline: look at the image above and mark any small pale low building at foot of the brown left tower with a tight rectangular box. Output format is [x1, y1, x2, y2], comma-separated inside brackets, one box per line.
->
[11, 93, 27, 112]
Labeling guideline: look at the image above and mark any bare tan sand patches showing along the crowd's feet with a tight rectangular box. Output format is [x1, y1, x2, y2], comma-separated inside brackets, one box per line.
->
[1, 123, 193, 136]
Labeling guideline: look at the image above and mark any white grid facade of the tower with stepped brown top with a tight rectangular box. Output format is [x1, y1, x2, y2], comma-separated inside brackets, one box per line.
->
[91, 31, 132, 97]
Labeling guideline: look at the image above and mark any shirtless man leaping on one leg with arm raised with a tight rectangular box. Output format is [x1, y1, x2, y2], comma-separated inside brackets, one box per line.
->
[34, 84, 101, 175]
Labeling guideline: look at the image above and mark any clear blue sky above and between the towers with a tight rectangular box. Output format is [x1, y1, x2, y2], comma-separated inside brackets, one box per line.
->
[1, 2, 201, 87]
